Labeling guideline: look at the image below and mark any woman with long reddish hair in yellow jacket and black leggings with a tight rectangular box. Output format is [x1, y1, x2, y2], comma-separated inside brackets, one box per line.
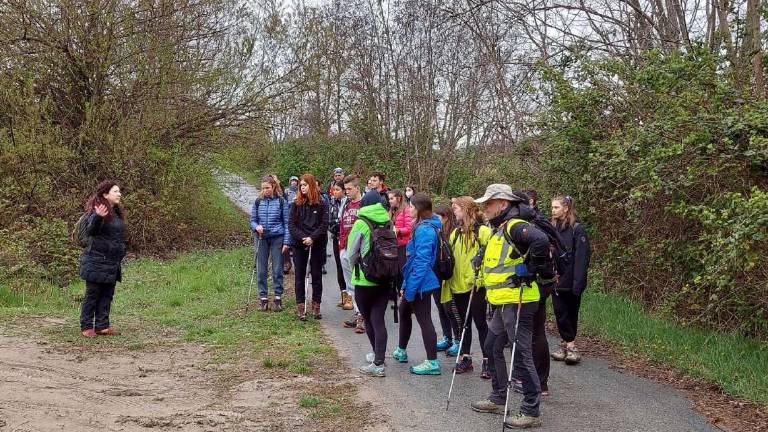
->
[440, 196, 491, 379]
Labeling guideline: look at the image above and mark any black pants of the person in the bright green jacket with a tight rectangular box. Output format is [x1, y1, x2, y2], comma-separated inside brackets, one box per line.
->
[355, 286, 390, 366]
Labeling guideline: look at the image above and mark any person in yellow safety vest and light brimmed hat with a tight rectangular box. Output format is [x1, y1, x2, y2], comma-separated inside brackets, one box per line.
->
[472, 184, 555, 429]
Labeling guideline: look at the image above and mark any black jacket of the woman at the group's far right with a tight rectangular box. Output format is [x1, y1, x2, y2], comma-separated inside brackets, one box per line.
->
[556, 222, 592, 295]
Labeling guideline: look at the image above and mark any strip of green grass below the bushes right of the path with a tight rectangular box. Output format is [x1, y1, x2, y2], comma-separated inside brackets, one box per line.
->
[579, 290, 768, 404]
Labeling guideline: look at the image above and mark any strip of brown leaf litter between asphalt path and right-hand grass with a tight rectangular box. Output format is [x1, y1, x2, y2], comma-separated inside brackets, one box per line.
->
[548, 322, 768, 432]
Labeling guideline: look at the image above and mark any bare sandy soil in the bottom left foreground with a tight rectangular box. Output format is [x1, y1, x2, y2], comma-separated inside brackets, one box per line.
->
[0, 332, 376, 432]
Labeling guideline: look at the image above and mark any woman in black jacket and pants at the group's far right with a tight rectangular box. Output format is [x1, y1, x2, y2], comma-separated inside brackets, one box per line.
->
[552, 196, 591, 365]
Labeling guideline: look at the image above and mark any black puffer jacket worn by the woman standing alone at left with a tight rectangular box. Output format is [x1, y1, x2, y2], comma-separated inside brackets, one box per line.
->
[80, 210, 125, 284]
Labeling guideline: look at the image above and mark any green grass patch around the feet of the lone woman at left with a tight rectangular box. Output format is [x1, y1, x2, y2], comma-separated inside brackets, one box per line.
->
[0, 248, 335, 375]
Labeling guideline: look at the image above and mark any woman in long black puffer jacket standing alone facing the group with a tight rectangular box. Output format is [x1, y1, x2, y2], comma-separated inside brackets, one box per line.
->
[80, 180, 125, 337]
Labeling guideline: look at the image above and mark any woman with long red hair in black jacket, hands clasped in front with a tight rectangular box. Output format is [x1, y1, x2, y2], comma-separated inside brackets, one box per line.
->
[288, 174, 329, 321]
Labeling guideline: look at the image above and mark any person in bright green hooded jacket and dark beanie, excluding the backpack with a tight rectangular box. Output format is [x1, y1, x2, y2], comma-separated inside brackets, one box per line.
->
[347, 190, 390, 377]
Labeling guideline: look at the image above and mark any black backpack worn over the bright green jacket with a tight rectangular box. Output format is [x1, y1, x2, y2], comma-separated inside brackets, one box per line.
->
[355, 215, 401, 285]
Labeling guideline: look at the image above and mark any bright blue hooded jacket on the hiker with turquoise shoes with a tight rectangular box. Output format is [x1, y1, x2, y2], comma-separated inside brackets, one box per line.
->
[403, 214, 442, 301]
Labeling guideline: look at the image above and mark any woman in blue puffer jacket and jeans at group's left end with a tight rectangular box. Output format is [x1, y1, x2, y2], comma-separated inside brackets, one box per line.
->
[251, 176, 291, 312]
